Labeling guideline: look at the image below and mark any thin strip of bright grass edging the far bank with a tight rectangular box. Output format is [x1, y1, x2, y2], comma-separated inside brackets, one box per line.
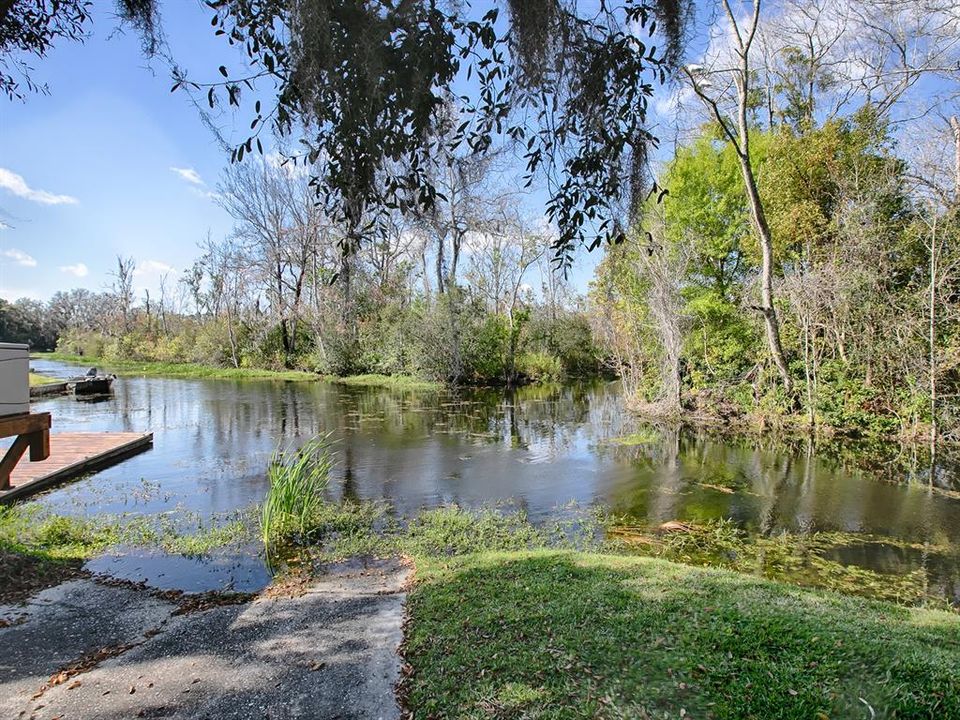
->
[31, 352, 442, 390]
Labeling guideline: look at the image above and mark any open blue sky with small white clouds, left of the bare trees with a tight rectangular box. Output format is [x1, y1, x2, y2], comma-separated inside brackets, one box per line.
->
[0, 0, 240, 299]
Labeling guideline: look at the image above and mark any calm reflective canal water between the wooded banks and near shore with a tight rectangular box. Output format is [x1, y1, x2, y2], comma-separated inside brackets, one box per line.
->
[33, 361, 960, 597]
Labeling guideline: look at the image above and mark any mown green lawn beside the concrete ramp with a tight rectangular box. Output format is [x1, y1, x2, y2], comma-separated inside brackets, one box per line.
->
[404, 550, 960, 720]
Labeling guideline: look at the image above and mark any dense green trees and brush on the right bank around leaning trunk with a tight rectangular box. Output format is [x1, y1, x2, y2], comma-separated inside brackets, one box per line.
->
[591, 118, 960, 439]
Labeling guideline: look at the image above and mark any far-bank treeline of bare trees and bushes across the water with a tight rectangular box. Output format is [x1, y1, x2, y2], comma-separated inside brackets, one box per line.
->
[2, 158, 605, 384]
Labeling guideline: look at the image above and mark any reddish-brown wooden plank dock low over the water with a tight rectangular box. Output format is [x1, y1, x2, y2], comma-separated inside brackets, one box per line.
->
[0, 432, 153, 503]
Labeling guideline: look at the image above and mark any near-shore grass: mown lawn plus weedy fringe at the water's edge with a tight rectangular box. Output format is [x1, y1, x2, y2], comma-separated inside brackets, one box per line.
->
[7, 484, 960, 720]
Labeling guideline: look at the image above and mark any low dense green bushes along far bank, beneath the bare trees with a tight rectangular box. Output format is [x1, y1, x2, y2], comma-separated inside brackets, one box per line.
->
[56, 299, 599, 385]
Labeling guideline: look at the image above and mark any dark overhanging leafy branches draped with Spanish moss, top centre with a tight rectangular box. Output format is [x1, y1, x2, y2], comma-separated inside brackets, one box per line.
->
[174, 0, 689, 272]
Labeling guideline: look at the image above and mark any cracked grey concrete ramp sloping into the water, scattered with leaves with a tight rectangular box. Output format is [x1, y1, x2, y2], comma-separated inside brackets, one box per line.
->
[0, 561, 409, 720]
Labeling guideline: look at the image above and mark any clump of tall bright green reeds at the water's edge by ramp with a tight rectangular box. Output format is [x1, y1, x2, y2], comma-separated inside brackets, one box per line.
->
[260, 435, 333, 547]
